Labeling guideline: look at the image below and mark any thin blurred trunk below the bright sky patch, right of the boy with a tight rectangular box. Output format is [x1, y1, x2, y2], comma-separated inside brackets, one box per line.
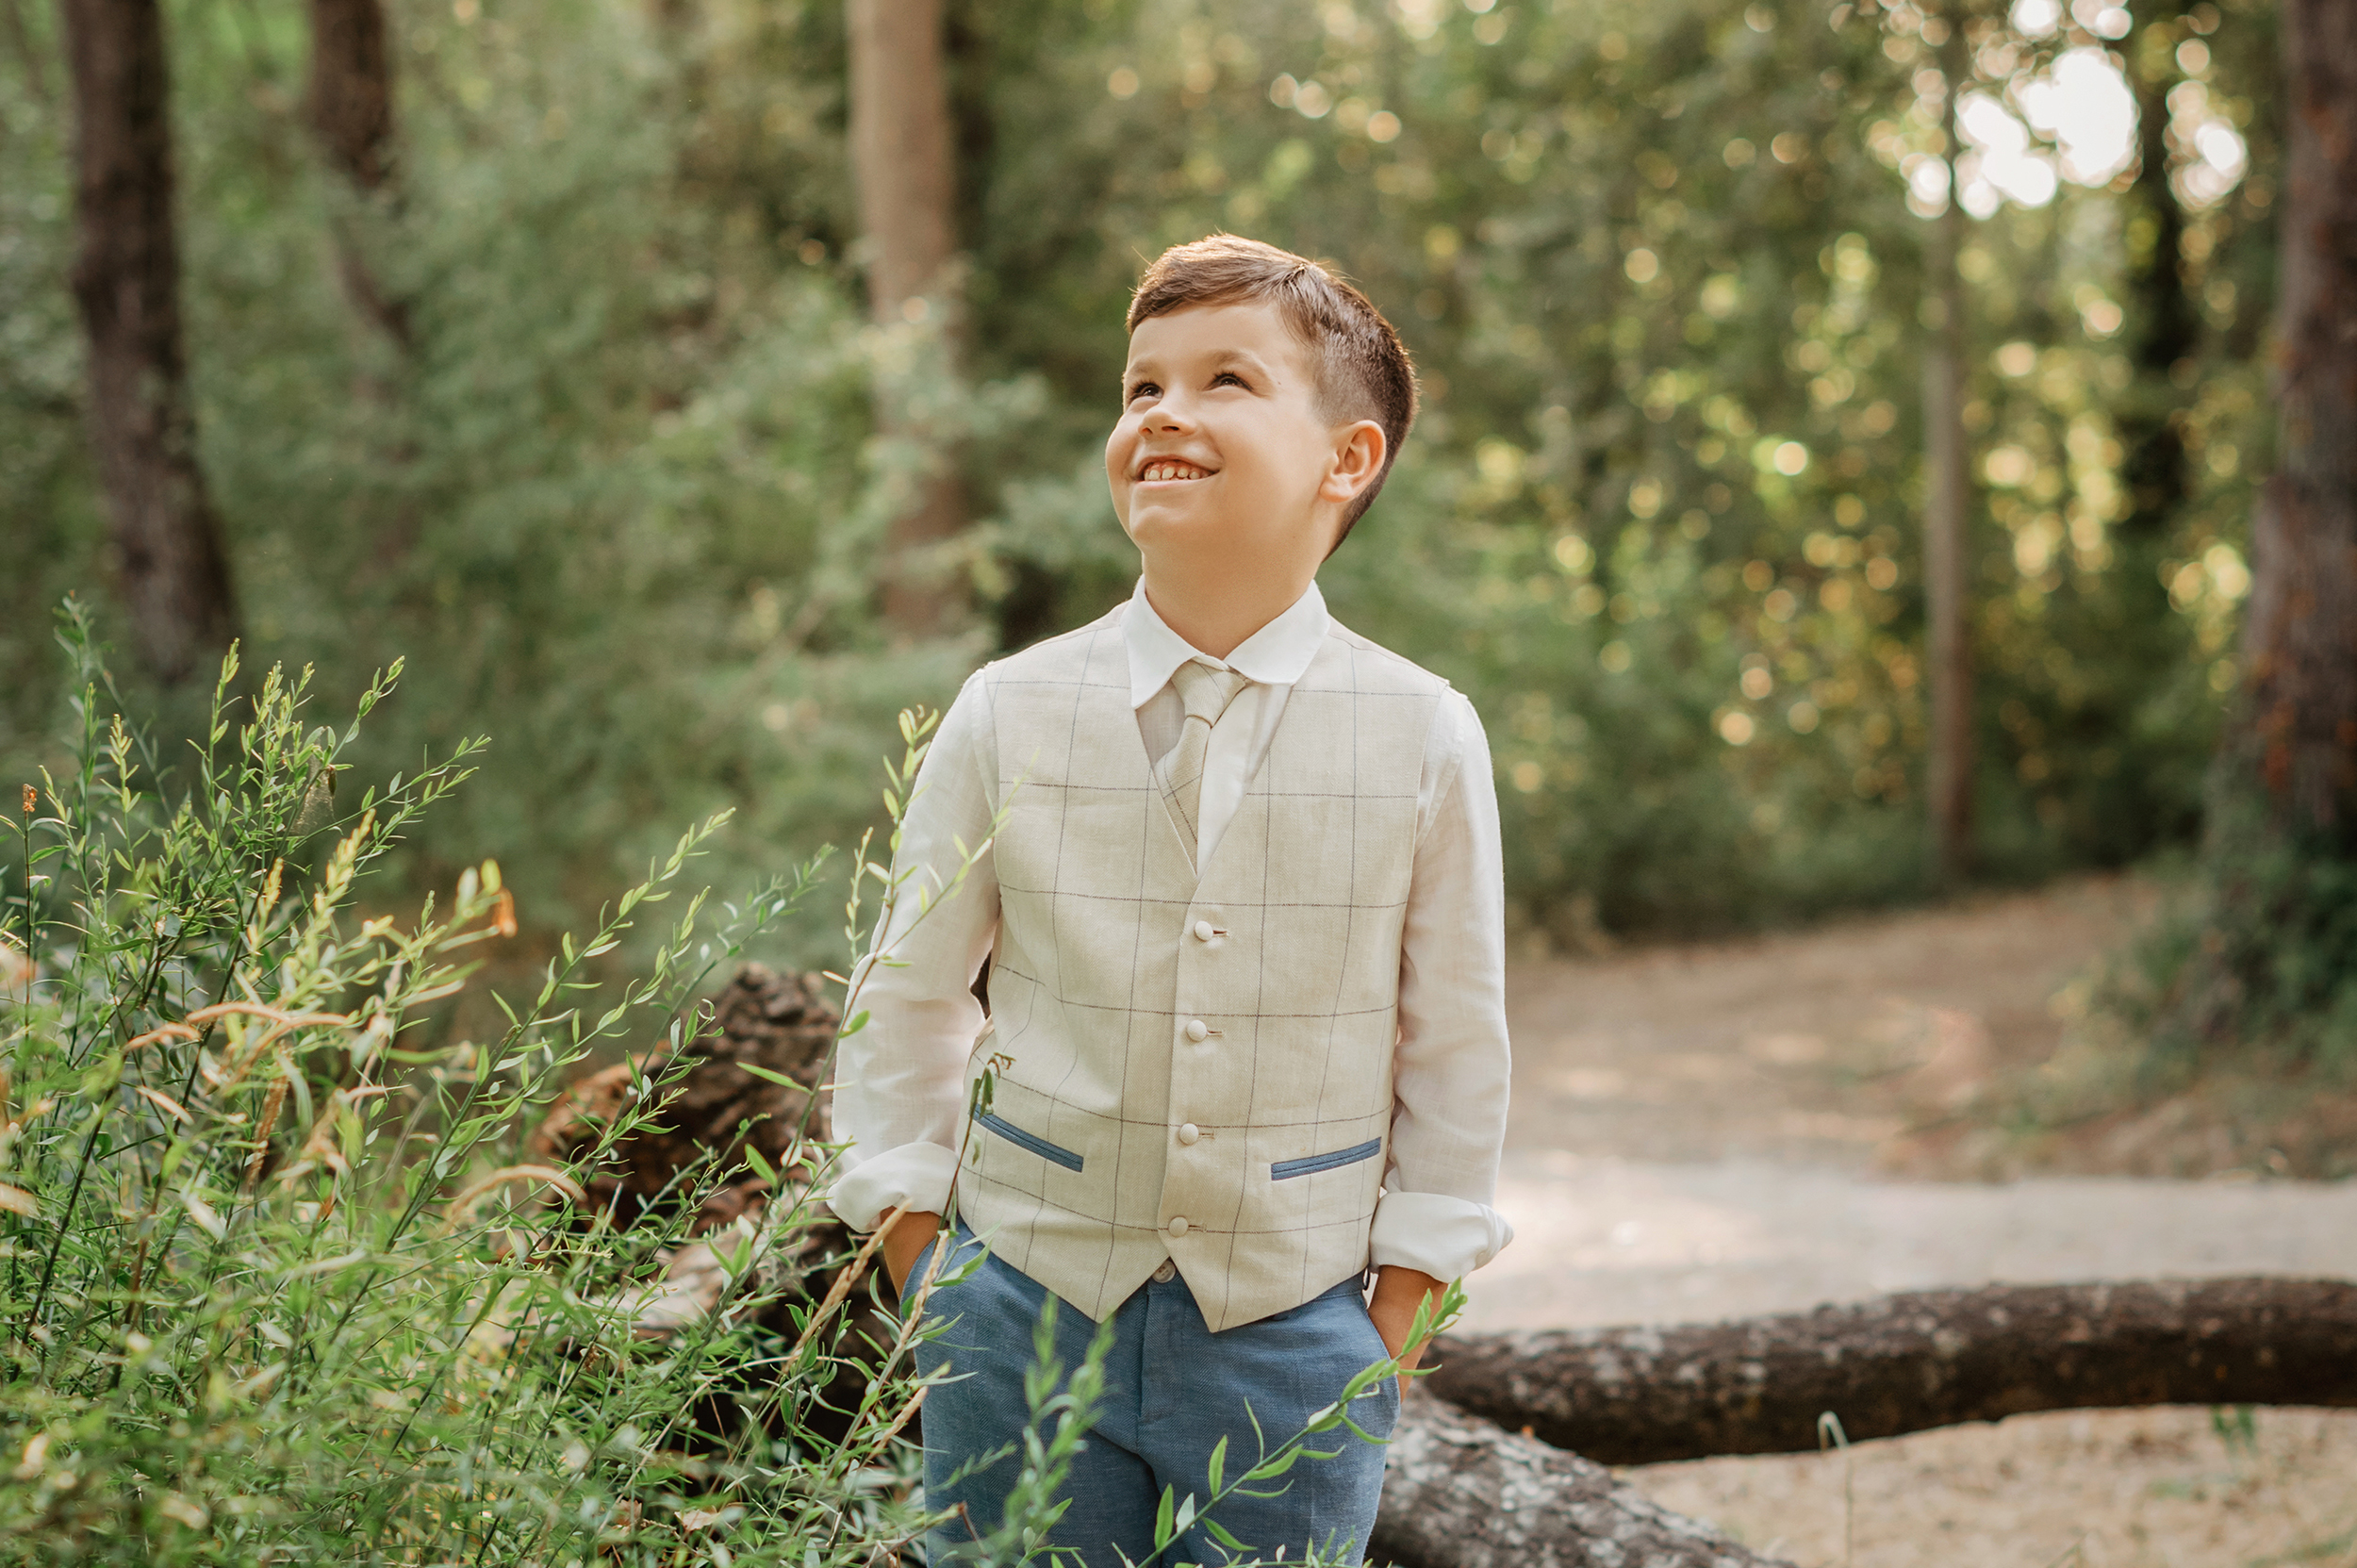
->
[1923, 19, 1973, 886]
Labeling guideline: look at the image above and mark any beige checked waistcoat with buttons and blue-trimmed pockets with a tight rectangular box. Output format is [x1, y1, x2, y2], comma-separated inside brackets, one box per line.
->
[957, 611, 1447, 1332]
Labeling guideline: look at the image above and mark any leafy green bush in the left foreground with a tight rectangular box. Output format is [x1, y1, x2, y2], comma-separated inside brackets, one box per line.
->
[0, 622, 976, 1565]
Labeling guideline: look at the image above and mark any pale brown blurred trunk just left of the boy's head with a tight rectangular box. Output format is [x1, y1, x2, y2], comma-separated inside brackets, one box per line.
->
[844, 0, 966, 636]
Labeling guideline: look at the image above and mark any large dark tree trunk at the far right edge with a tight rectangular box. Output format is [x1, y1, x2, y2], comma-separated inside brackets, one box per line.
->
[2171, 0, 2357, 1064]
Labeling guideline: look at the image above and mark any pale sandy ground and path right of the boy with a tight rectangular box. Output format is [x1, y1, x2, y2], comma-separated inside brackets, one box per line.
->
[1466, 880, 2357, 1568]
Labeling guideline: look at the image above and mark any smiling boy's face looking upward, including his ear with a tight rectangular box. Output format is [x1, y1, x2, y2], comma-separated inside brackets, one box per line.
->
[1106, 302, 1381, 583]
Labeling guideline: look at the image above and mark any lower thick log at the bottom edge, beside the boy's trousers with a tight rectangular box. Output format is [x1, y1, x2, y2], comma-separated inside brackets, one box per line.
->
[1367, 1389, 1777, 1568]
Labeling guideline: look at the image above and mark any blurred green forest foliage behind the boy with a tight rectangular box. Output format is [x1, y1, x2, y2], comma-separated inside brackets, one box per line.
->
[0, 0, 2282, 960]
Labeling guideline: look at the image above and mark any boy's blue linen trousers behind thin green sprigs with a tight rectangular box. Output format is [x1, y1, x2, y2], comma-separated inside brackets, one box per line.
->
[910, 1226, 1400, 1568]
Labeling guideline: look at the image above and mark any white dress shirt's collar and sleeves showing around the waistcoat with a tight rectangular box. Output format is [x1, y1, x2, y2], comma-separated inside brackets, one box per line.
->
[828, 578, 1513, 1280]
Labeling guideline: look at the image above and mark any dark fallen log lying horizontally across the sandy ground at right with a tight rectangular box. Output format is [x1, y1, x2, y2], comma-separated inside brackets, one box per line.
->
[1428, 1278, 2357, 1464]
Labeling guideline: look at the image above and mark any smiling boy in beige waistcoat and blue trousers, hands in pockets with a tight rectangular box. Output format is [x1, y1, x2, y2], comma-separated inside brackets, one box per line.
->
[830, 236, 1511, 1568]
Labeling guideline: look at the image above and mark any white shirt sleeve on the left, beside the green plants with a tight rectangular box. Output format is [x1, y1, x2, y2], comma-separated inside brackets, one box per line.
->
[828, 674, 999, 1230]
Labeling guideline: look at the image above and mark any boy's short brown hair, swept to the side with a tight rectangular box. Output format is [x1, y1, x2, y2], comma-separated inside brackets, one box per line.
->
[1129, 234, 1417, 550]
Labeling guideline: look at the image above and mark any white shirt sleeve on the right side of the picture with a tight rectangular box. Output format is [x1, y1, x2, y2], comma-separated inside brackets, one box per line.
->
[1367, 693, 1513, 1280]
